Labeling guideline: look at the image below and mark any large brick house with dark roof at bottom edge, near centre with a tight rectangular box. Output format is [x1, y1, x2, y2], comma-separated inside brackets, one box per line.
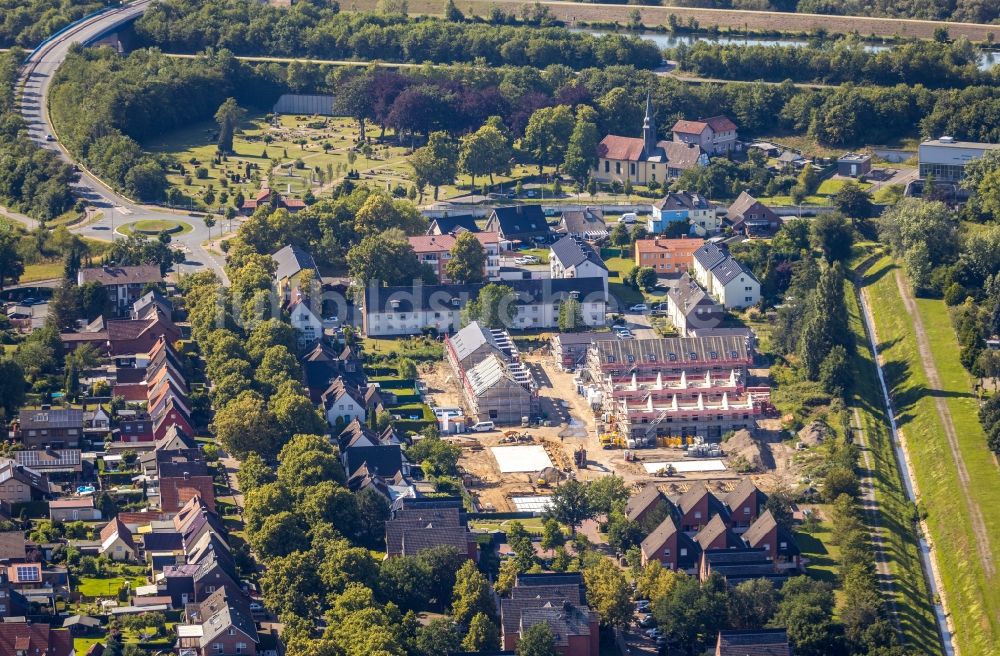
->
[500, 573, 600, 656]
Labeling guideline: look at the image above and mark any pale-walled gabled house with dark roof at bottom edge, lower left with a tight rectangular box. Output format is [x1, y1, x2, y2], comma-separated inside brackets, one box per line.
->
[177, 586, 260, 656]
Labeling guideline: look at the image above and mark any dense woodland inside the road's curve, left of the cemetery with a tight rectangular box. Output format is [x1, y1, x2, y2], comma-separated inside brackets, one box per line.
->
[49, 48, 280, 200]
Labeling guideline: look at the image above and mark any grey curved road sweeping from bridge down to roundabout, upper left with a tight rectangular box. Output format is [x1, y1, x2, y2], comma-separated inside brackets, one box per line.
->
[18, 0, 228, 284]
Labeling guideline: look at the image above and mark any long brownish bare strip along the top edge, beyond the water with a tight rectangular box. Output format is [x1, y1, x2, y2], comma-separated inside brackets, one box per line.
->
[342, 0, 1000, 41]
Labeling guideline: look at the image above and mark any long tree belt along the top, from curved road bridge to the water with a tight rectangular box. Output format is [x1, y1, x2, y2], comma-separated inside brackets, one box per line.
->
[136, 0, 662, 69]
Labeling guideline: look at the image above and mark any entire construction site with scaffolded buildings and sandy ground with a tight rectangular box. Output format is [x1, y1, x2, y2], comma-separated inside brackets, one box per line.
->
[420, 332, 795, 512]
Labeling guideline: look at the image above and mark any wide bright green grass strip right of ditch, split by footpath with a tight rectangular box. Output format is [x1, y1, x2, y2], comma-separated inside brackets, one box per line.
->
[859, 258, 1000, 656]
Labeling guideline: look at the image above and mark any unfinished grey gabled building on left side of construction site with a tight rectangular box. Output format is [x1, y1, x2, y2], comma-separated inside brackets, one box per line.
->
[445, 321, 538, 424]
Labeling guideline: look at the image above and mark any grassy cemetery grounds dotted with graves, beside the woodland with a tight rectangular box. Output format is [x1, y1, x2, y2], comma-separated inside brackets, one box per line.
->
[143, 114, 568, 209]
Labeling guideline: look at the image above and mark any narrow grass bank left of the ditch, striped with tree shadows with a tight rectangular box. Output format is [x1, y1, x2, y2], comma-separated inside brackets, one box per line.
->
[845, 270, 940, 654]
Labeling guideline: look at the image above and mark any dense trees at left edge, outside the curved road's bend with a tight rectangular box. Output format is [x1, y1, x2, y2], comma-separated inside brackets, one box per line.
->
[0, 50, 76, 220]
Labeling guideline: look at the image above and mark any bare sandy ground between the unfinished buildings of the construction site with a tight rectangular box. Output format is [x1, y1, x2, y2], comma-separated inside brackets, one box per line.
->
[420, 353, 796, 512]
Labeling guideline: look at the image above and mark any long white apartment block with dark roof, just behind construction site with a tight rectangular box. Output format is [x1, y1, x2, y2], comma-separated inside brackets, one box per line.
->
[363, 278, 608, 337]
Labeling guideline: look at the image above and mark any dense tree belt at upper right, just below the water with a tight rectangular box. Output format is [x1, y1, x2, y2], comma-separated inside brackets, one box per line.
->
[672, 38, 1000, 88]
